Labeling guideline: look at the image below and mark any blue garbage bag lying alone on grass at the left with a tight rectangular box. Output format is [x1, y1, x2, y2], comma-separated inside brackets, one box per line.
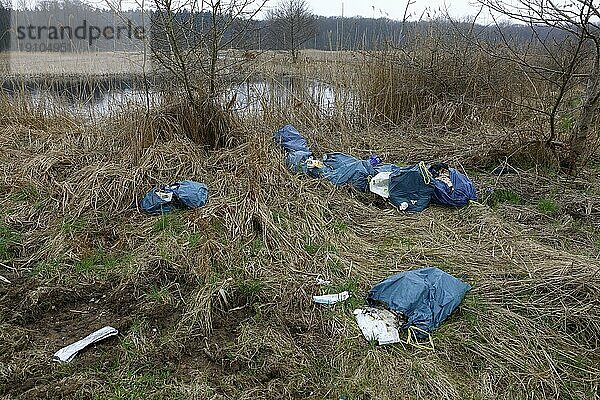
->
[140, 181, 208, 214]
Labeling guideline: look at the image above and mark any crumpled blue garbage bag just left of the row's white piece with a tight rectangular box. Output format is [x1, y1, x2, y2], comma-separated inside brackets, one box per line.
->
[323, 153, 376, 192]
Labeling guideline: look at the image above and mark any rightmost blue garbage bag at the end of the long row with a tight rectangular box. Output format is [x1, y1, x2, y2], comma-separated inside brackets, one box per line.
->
[429, 164, 477, 207]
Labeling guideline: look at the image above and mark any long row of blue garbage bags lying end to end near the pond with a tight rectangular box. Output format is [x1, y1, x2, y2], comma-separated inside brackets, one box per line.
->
[274, 125, 477, 212]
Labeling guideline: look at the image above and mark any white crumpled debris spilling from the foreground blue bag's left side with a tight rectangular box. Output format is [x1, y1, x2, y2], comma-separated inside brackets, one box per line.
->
[354, 307, 400, 345]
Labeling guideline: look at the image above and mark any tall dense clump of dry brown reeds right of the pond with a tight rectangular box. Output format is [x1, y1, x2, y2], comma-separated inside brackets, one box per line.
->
[361, 31, 521, 127]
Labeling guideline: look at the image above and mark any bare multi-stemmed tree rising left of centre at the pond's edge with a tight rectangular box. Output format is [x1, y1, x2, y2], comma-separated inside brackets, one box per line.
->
[152, 0, 267, 104]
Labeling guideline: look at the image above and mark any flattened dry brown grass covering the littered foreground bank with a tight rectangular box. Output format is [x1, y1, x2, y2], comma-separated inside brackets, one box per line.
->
[0, 89, 600, 399]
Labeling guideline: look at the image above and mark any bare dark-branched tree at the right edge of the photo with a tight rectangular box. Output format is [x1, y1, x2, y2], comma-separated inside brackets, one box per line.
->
[479, 0, 600, 175]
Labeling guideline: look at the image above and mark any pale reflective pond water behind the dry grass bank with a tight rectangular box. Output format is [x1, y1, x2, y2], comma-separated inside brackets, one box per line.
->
[3, 76, 351, 119]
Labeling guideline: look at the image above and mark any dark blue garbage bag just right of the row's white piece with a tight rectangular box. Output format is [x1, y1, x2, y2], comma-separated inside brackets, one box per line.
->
[388, 163, 434, 212]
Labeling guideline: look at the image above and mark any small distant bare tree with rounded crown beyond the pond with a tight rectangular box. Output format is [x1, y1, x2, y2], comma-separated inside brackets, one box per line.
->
[267, 0, 316, 62]
